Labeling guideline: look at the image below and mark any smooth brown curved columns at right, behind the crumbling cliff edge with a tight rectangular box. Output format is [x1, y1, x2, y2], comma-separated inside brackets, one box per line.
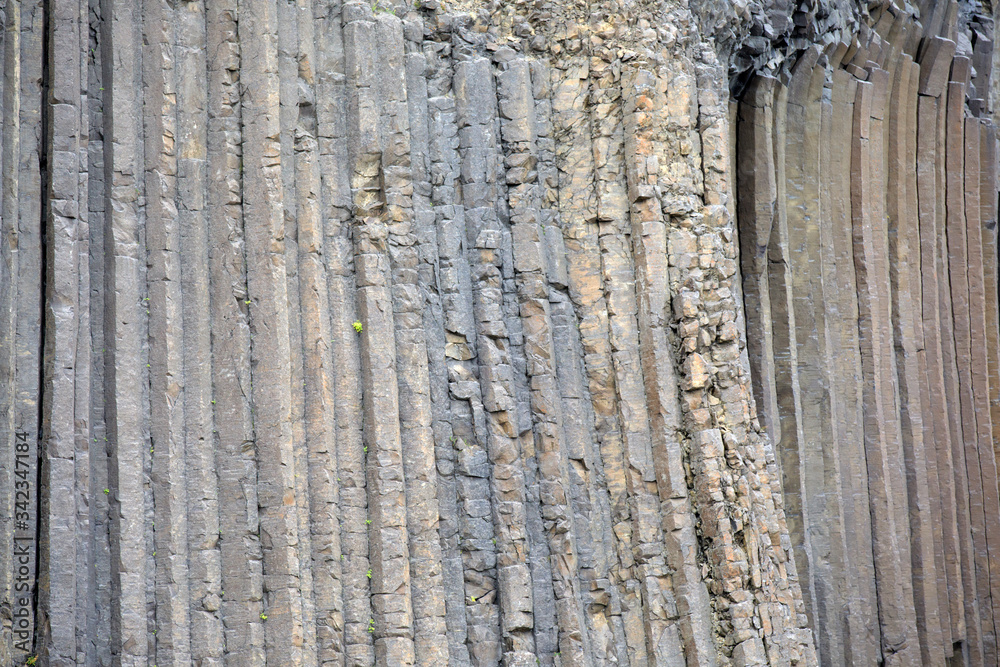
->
[737, 6, 1000, 665]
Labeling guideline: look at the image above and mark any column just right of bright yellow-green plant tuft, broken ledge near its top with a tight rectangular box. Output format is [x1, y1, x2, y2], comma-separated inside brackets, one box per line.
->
[344, 7, 415, 665]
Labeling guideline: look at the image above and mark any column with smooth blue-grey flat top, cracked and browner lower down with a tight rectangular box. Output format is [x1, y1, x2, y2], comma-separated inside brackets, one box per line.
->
[454, 58, 537, 667]
